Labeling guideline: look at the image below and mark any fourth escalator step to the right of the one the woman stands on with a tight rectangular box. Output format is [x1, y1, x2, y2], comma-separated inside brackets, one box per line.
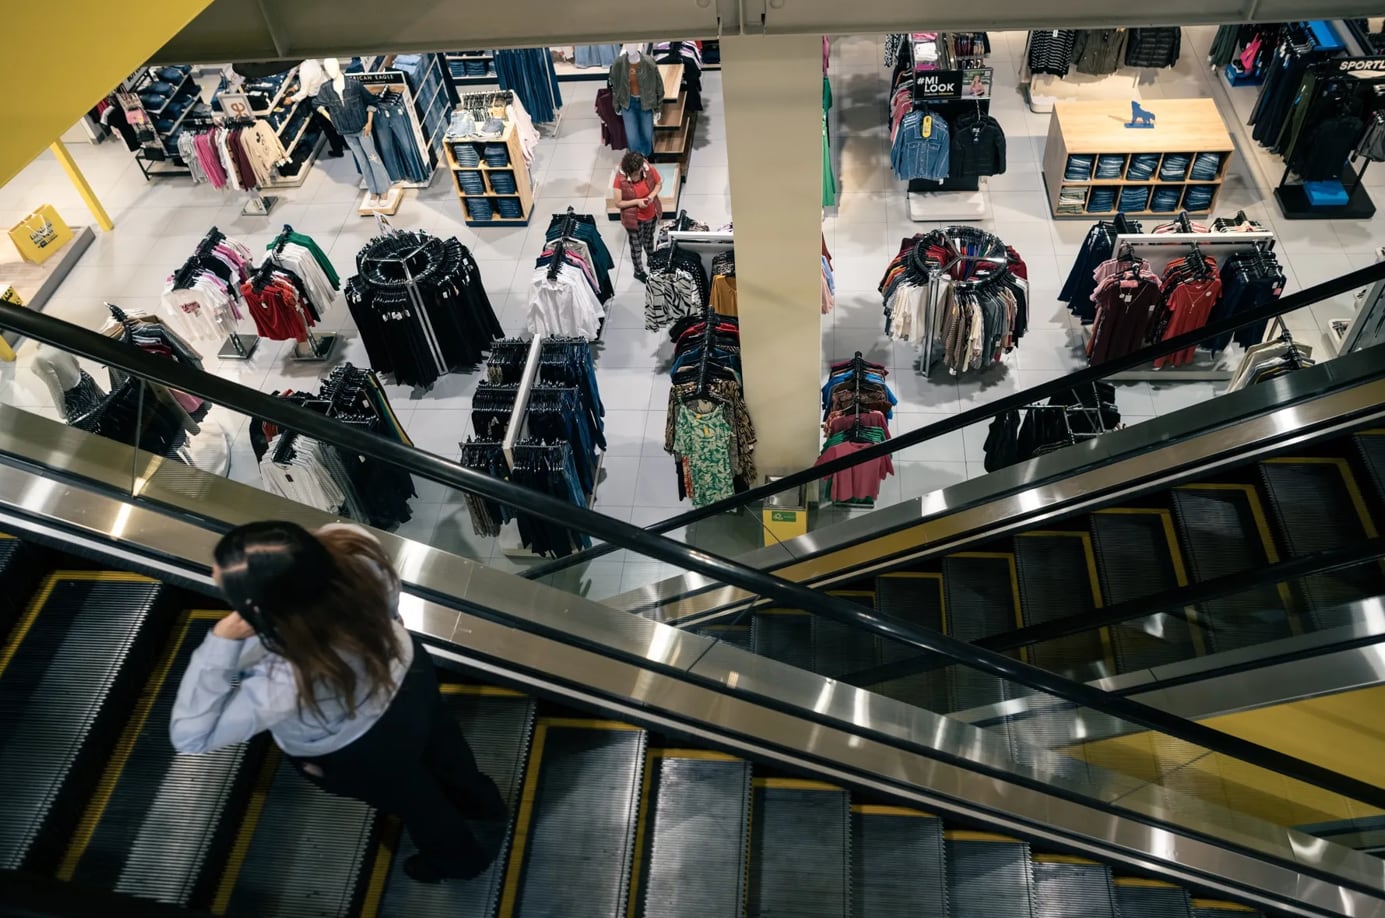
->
[852, 806, 947, 918]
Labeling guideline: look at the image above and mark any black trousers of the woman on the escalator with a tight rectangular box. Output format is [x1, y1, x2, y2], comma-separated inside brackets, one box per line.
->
[294, 638, 506, 875]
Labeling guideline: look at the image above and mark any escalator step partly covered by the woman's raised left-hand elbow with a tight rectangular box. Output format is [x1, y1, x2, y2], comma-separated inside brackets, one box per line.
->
[58, 612, 262, 906]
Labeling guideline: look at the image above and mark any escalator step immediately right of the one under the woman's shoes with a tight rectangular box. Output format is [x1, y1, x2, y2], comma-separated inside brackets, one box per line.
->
[500, 719, 647, 918]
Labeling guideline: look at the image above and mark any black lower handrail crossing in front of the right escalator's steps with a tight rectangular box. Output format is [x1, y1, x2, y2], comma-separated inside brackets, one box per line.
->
[837, 539, 1385, 687]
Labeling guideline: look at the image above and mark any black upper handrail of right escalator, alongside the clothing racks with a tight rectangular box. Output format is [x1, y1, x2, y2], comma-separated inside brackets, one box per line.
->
[519, 262, 1385, 580]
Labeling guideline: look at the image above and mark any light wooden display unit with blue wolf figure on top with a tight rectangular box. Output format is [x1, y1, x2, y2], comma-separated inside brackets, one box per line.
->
[1043, 98, 1235, 220]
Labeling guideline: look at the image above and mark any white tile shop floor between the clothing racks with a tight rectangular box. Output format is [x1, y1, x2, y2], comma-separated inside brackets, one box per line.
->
[0, 28, 1385, 595]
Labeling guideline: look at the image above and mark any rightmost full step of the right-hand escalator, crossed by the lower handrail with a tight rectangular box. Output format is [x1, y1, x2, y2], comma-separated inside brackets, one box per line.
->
[1260, 457, 1385, 618]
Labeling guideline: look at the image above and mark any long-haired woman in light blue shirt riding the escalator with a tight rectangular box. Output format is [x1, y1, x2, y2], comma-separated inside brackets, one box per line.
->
[170, 522, 506, 882]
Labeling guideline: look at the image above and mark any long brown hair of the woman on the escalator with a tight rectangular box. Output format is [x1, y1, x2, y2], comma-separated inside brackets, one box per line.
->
[213, 521, 402, 717]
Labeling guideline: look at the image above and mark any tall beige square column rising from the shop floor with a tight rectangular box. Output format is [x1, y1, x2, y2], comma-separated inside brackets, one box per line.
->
[714, 35, 823, 476]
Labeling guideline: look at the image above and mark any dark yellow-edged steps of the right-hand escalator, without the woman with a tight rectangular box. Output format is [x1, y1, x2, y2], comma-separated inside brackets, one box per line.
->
[714, 422, 1385, 713]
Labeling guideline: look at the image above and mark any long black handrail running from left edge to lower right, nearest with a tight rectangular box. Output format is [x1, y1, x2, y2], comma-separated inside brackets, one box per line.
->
[0, 302, 1385, 809]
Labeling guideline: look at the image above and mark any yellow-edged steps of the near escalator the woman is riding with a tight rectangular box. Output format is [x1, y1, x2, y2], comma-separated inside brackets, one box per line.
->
[0, 537, 1296, 918]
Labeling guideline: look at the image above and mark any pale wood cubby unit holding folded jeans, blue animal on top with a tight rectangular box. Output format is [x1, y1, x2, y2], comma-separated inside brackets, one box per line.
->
[1043, 98, 1234, 220]
